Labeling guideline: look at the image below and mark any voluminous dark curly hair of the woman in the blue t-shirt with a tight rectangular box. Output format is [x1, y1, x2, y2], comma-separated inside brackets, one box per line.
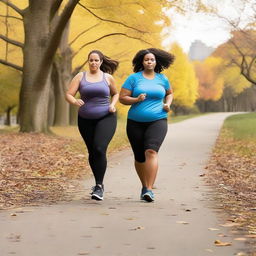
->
[132, 48, 175, 73]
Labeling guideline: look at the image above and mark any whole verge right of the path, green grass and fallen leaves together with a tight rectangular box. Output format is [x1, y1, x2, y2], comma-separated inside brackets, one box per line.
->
[206, 113, 256, 252]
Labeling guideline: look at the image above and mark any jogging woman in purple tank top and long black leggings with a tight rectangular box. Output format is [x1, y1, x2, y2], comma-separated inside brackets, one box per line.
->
[66, 50, 119, 200]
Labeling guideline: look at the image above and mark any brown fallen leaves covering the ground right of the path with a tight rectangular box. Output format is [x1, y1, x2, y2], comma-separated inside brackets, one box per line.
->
[207, 129, 256, 238]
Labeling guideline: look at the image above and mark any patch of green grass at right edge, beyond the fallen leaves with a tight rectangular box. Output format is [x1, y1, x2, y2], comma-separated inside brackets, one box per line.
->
[224, 112, 256, 140]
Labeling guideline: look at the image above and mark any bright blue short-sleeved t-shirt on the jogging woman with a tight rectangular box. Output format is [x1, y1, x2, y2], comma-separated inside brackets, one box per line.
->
[122, 71, 171, 122]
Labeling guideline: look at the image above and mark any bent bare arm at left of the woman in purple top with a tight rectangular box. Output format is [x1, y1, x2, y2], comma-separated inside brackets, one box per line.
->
[65, 72, 84, 107]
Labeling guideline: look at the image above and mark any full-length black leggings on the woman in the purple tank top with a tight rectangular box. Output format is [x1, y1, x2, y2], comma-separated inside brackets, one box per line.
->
[78, 113, 117, 184]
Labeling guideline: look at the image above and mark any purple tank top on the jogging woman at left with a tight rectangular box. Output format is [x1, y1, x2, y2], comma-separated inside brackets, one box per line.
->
[78, 72, 110, 119]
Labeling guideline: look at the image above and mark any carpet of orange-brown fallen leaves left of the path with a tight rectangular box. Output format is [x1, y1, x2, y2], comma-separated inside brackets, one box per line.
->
[0, 134, 87, 208]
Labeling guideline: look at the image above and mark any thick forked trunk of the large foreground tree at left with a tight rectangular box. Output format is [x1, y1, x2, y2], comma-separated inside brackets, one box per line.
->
[19, 0, 79, 132]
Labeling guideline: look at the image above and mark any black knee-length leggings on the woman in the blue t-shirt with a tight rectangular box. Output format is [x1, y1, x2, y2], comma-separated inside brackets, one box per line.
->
[126, 119, 167, 163]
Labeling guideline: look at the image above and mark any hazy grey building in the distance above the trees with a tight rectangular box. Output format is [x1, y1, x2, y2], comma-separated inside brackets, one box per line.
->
[188, 40, 215, 60]
